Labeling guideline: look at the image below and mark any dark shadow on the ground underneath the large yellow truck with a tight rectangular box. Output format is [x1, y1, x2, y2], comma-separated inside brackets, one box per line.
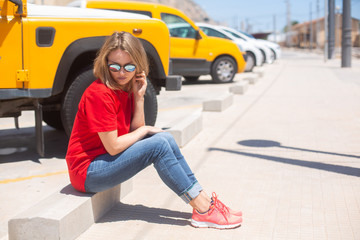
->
[0, 126, 68, 164]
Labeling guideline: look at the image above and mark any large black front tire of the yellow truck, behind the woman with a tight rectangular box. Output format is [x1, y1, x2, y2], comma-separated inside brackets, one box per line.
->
[61, 69, 157, 136]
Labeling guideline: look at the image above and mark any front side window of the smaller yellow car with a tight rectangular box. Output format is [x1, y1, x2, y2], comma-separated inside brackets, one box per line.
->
[161, 13, 196, 38]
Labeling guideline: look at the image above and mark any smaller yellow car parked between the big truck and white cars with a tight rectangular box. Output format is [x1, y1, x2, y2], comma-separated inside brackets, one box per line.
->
[73, 0, 246, 83]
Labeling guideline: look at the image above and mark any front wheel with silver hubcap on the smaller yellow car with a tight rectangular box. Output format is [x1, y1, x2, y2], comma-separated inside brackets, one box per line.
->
[211, 57, 237, 83]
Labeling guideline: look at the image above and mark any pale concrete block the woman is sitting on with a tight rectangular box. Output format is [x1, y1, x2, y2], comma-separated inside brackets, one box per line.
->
[9, 180, 132, 240]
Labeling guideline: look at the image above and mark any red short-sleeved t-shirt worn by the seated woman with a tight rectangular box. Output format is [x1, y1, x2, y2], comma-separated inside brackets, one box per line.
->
[66, 79, 134, 192]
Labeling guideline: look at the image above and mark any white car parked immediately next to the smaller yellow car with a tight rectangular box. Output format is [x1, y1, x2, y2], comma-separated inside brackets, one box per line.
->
[196, 23, 263, 72]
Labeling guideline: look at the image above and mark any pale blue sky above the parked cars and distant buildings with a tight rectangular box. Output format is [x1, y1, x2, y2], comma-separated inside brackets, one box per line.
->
[194, 0, 360, 33]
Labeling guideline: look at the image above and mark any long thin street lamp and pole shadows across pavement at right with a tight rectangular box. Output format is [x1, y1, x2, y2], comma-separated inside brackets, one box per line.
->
[208, 140, 360, 177]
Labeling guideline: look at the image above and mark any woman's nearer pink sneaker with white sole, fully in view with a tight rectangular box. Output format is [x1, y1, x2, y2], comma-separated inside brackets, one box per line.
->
[191, 195, 242, 229]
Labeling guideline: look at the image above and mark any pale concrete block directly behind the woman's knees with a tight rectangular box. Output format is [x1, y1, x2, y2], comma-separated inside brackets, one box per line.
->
[167, 110, 202, 147]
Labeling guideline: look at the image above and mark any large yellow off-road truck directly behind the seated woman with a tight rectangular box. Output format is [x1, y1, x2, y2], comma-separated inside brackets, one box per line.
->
[0, 0, 181, 155]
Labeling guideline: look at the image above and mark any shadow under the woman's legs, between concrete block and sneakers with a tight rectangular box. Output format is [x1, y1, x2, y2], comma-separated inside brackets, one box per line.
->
[98, 202, 192, 226]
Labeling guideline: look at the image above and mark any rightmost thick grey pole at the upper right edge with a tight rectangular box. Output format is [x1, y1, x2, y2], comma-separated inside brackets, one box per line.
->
[341, 0, 351, 67]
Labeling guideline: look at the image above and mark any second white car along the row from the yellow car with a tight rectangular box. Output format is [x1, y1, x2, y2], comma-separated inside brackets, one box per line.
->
[221, 26, 275, 63]
